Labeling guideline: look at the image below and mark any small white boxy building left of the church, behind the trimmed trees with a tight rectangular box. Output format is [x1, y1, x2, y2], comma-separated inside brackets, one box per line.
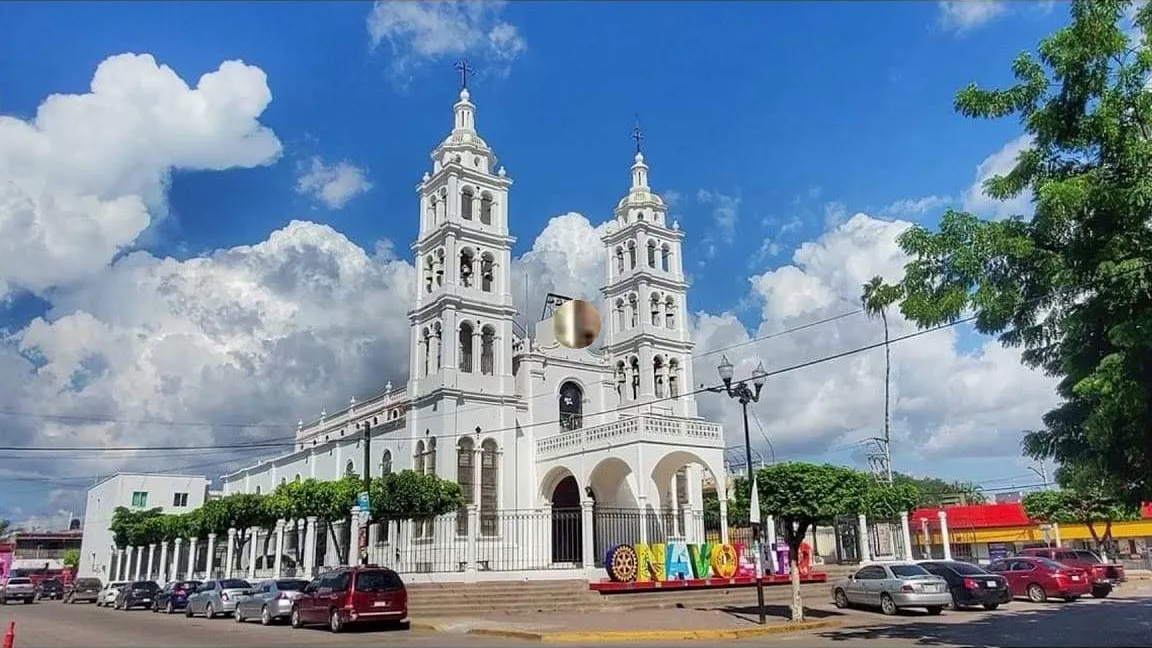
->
[77, 474, 209, 581]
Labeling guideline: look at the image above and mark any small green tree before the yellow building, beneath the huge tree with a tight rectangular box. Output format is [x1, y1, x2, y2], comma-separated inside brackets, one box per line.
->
[1021, 465, 1140, 552]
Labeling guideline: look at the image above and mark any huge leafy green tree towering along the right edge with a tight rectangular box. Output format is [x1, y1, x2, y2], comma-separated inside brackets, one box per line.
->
[884, 0, 1152, 504]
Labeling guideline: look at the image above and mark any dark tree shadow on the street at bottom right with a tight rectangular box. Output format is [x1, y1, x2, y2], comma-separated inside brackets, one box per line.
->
[814, 598, 1152, 648]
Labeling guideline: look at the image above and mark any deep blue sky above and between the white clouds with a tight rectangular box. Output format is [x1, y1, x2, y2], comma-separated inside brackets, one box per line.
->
[0, 1, 1067, 525]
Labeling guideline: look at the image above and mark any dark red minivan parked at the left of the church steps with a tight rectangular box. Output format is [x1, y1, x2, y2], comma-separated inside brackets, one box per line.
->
[291, 565, 408, 632]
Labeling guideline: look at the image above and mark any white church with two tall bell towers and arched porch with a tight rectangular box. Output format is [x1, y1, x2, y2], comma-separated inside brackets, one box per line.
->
[222, 83, 725, 572]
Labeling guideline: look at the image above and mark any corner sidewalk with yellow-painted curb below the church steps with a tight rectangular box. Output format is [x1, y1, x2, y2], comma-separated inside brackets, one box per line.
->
[411, 605, 841, 642]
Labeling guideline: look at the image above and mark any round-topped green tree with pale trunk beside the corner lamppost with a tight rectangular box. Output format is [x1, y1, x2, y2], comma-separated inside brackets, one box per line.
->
[756, 462, 876, 621]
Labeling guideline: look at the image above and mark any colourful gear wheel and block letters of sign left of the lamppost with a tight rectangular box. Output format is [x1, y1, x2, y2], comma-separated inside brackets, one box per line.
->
[604, 542, 756, 582]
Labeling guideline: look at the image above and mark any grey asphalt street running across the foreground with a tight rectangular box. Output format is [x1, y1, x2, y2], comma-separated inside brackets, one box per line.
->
[0, 588, 1152, 648]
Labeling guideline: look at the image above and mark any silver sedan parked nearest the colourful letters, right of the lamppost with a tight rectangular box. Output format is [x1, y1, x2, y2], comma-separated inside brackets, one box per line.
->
[832, 563, 952, 615]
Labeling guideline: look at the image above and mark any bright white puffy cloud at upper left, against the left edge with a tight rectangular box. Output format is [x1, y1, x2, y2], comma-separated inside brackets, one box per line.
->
[0, 54, 280, 299]
